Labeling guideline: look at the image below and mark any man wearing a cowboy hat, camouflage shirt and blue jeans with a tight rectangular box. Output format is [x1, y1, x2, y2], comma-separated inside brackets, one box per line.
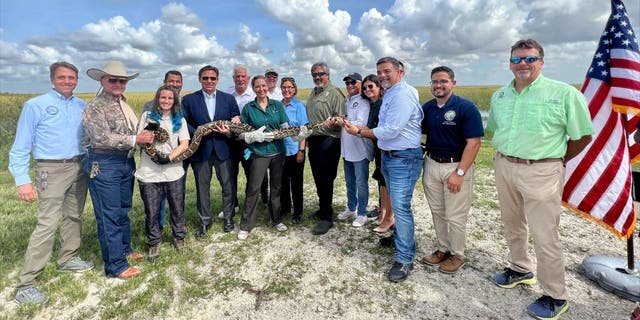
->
[82, 61, 154, 279]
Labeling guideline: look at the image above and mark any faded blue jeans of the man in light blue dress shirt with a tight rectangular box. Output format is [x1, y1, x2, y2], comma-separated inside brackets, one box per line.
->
[382, 148, 422, 264]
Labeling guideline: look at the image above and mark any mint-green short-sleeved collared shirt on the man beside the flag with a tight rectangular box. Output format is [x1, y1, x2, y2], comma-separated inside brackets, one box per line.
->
[487, 75, 594, 160]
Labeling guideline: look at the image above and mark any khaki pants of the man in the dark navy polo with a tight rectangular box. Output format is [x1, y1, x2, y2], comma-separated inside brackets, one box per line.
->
[422, 157, 474, 257]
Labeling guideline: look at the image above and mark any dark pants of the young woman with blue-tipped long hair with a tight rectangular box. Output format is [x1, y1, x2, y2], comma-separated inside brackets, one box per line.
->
[138, 178, 187, 246]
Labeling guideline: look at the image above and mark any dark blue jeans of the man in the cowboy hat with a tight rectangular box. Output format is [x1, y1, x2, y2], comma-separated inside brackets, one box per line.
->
[84, 152, 136, 277]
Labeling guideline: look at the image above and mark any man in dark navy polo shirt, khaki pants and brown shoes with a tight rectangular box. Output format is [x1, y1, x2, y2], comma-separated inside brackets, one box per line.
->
[422, 66, 484, 273]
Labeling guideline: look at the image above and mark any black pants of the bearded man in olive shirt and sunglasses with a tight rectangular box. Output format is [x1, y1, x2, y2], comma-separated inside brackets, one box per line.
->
[307, 136, 340, 221]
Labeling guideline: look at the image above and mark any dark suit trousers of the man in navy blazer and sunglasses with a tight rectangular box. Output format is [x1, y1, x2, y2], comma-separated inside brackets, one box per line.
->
[191, 155, 234, 227]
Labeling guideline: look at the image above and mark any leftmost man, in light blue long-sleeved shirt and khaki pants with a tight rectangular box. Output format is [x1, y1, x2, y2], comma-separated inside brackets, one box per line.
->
[9, 62, 93, 304]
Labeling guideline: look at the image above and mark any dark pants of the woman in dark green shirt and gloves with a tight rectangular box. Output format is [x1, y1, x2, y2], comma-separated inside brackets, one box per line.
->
[240, 153, 284, 231]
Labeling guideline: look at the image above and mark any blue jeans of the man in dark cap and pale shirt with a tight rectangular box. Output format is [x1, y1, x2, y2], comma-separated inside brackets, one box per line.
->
[344, 158, 369, 216]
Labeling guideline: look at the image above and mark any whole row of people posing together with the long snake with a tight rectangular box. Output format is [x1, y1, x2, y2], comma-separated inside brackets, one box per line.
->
[9, 39, 594, 319]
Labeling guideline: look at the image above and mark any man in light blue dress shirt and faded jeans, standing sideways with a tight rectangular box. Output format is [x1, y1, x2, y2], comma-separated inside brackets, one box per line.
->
[358, 57, 423, 282]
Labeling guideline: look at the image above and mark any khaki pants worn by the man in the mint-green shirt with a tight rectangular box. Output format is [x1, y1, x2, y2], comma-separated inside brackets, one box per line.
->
[494, 155, 568, 300]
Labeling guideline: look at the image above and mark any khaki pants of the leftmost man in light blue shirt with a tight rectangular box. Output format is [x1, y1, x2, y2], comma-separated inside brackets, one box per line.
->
[18, 162, 87, 288]
